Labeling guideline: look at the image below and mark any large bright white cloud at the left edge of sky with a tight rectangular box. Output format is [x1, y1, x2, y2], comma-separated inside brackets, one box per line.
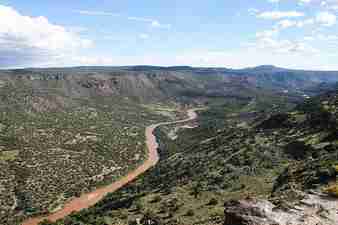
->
[0, 5, 93, 67]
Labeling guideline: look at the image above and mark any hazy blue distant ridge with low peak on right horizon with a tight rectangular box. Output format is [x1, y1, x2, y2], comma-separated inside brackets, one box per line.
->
[119, 65, 338, 91]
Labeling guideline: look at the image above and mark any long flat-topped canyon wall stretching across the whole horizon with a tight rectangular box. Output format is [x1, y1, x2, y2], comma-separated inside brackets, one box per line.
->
[0, 66, 338, 105]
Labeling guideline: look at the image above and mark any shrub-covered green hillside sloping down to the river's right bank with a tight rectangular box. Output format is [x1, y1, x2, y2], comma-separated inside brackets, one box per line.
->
[38, 87, 338, 225]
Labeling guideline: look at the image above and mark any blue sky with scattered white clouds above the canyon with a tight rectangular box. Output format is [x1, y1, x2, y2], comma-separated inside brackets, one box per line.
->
[0, 0, 338, 70]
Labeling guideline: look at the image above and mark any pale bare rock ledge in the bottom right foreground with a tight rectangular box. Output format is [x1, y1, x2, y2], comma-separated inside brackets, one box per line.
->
[224, 193, 338, 225]
